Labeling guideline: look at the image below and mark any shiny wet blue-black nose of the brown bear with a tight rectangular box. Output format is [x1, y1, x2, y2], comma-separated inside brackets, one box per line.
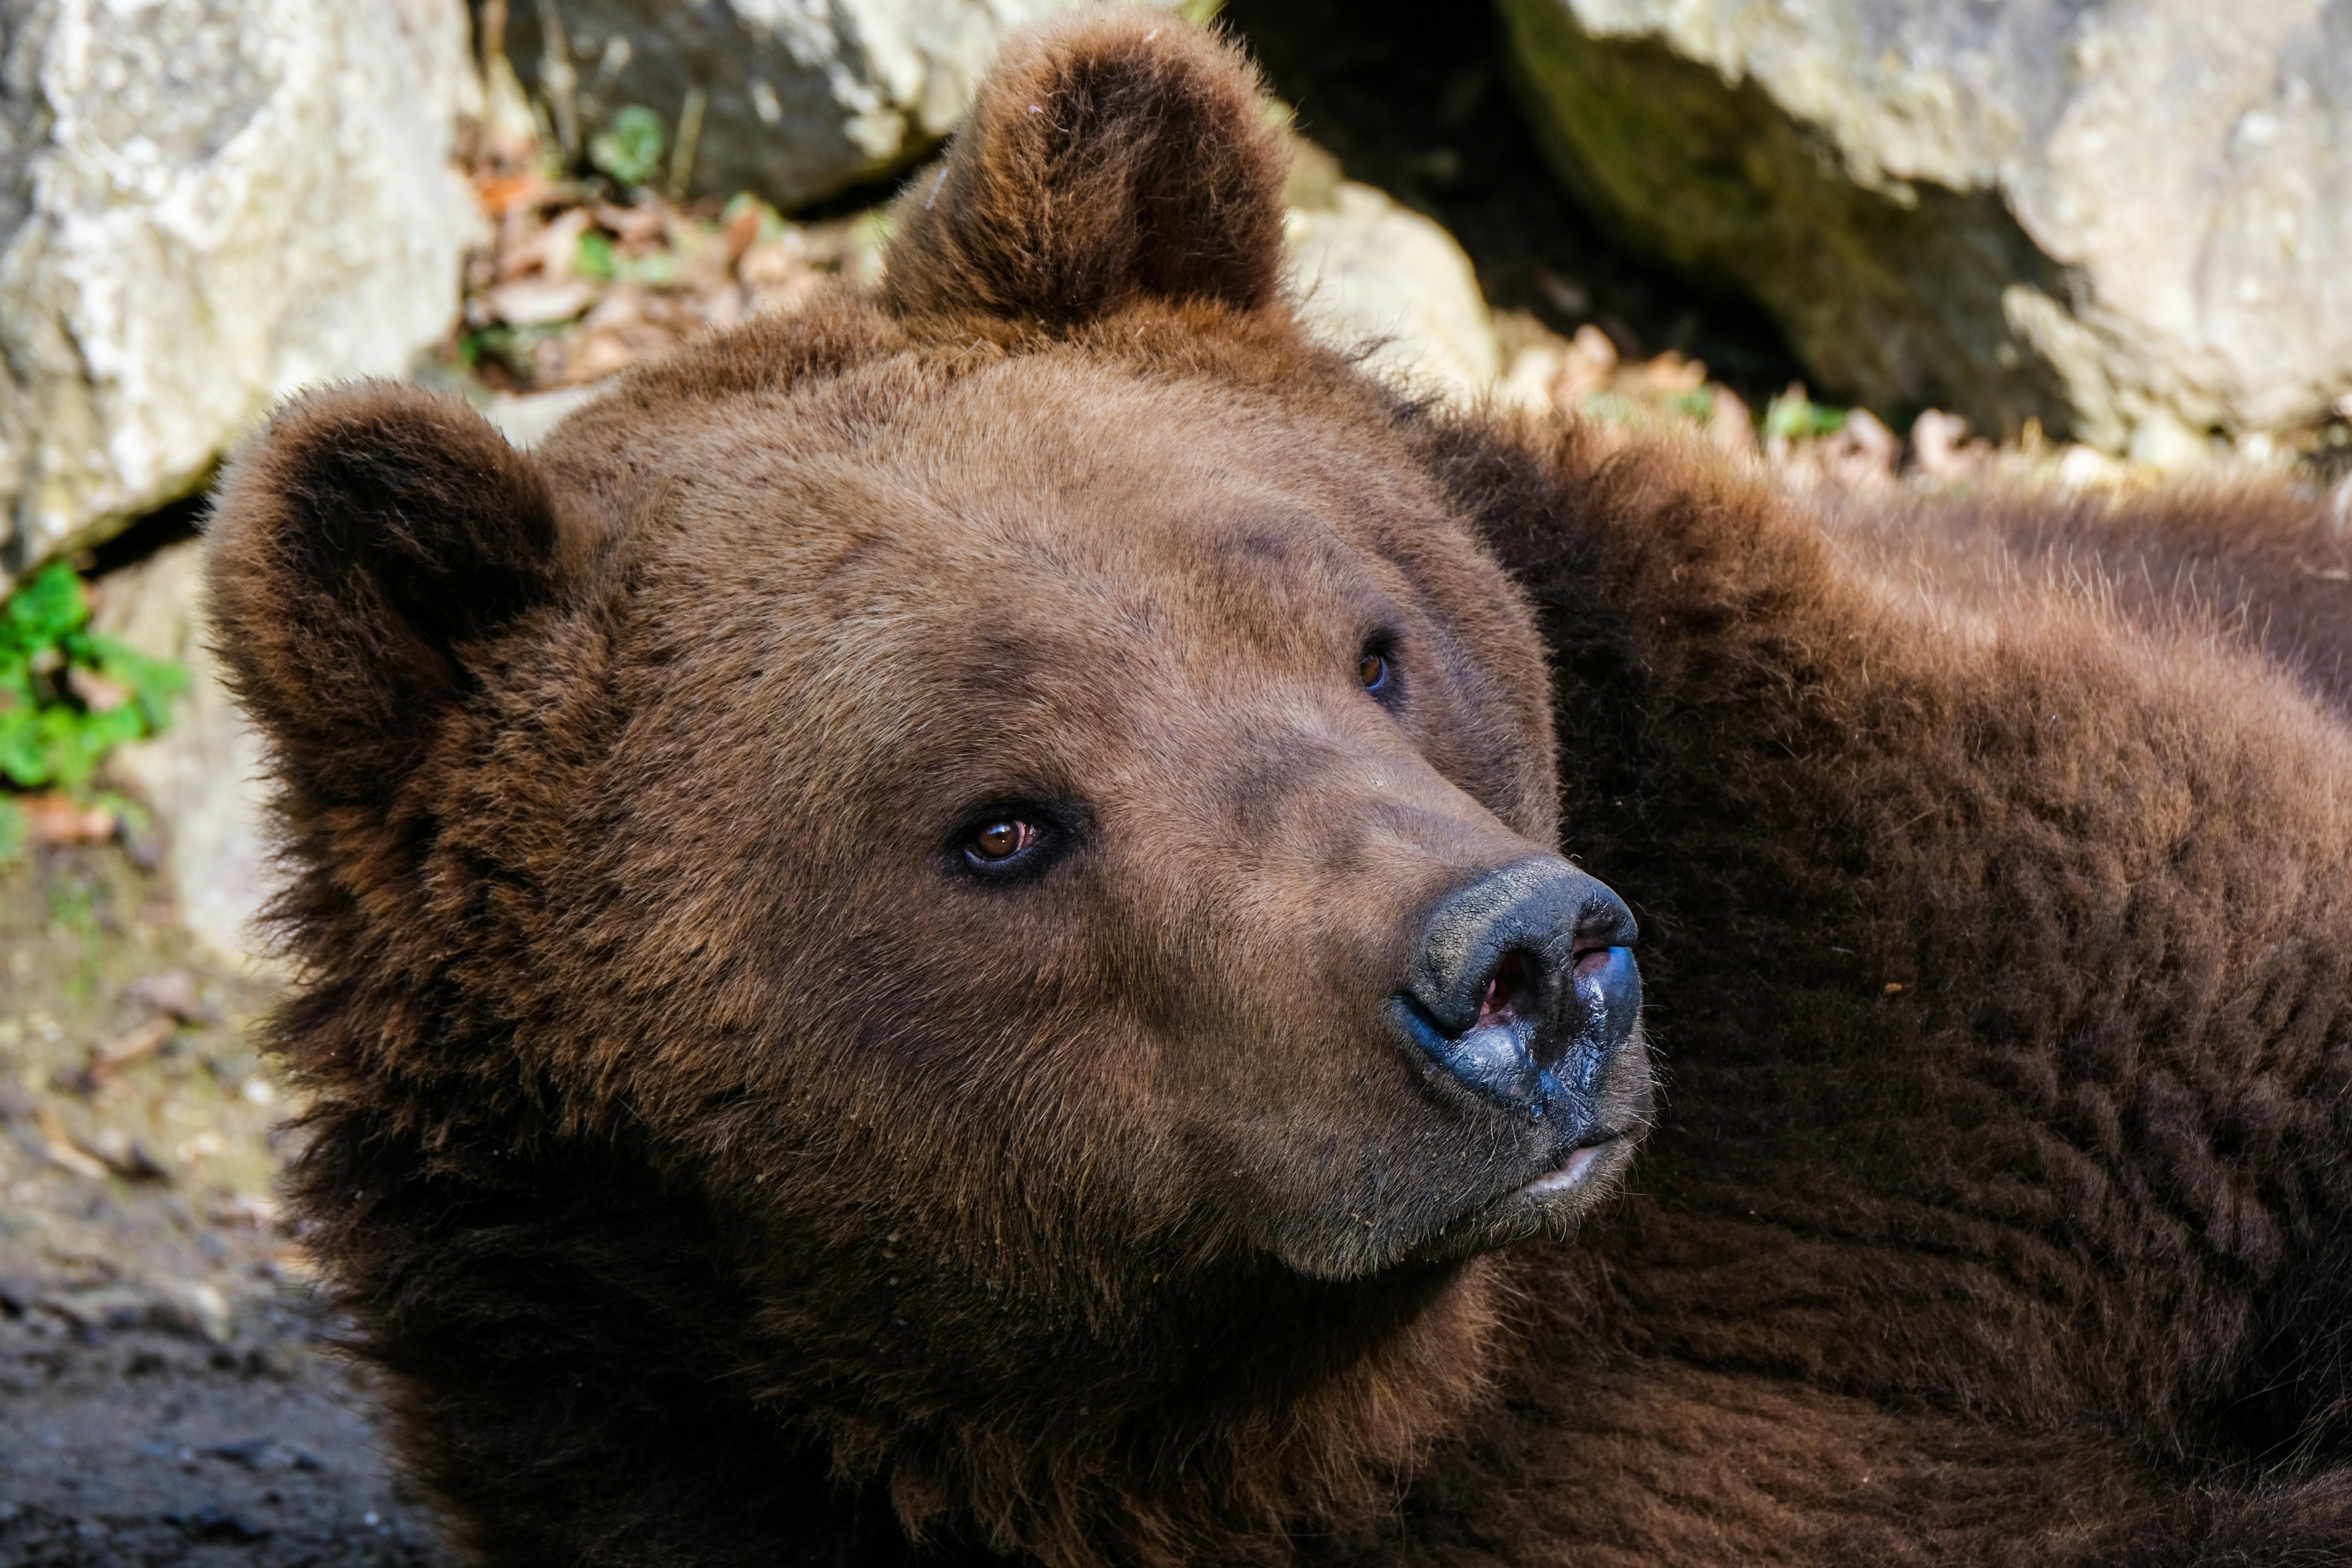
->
[1395, 856, 1642, 1117]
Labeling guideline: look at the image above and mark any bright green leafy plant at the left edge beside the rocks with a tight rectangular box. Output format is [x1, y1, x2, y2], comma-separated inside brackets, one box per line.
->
[0, 562, 188, 856]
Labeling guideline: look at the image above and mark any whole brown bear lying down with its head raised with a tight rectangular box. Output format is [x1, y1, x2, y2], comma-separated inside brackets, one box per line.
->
[209, 14, 2352, 1568]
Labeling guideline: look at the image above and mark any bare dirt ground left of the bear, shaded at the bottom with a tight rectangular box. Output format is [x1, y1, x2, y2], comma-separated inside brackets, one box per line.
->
[0, 844, 447, 1568]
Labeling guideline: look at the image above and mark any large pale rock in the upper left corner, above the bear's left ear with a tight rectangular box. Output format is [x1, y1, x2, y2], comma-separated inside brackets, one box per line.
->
[0, 0, 480, 588]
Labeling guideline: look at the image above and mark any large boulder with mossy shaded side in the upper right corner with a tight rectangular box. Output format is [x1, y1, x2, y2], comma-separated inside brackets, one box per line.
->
[1503, 0, 2352, 453]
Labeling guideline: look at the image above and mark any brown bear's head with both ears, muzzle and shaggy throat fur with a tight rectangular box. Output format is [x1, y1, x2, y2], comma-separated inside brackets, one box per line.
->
[209, 14, 1651, 1561]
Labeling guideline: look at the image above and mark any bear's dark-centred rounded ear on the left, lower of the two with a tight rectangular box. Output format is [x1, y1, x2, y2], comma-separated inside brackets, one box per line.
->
[205, 383, 579, 806]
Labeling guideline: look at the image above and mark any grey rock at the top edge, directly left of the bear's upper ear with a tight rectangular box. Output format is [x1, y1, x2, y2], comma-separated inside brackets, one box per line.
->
[506, 0, 1174, 209]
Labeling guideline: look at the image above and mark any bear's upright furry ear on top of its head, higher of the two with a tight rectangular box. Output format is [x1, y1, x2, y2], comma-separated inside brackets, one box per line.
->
[882, 9, 1289, 327]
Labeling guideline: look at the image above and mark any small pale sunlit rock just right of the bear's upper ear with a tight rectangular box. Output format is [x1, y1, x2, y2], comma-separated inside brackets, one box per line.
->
[1289, 181, 1503, 402]
